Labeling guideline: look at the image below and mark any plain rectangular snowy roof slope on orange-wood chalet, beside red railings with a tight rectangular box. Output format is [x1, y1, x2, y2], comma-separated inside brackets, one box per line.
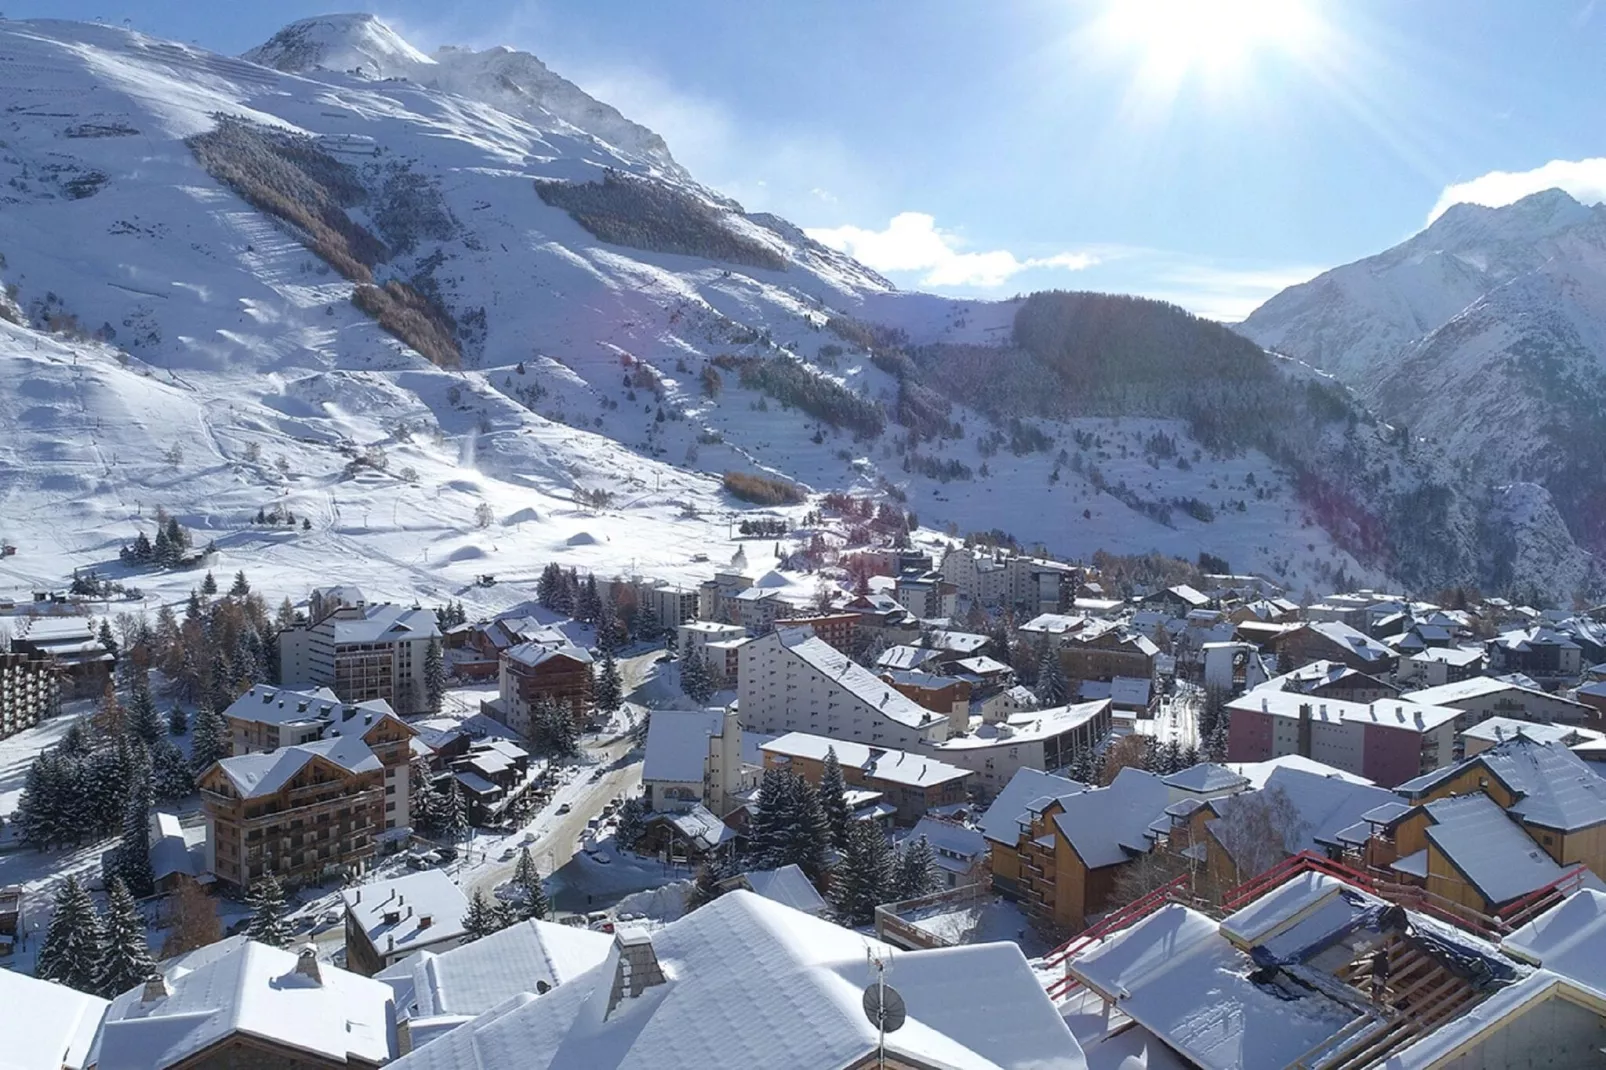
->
[1426, 794, 1566, 905]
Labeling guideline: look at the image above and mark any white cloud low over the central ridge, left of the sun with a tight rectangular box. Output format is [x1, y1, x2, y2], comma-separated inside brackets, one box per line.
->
[806, 212, 1099, 289]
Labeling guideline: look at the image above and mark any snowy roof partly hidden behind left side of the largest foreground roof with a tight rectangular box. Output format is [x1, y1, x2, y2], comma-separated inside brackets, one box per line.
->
[377, 921, 613, 1021]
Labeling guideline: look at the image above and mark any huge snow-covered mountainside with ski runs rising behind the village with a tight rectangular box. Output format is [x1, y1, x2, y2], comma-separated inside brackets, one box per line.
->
[0, 16, 1579, 601]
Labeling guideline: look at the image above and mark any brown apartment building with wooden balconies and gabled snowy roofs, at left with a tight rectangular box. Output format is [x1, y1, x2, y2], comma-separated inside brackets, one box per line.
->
[199, 692, 416, 892]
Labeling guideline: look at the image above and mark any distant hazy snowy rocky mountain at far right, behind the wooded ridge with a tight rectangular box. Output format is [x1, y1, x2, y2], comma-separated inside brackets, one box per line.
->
[1240, 190, 1606, 591]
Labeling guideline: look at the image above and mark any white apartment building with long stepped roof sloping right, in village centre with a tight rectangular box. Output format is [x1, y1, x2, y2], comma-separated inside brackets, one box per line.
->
[737, 628, 949, 750]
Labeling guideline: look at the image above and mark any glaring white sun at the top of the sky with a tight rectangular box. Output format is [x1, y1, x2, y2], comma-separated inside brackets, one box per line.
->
[1097, 0, 1322, 90]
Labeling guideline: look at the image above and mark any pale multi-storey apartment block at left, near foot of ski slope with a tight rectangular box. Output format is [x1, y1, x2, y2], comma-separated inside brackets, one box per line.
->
[279, 588, 440, 715]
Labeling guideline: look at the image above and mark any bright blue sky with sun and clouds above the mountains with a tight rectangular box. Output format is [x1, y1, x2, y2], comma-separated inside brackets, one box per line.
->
[3, 0, 1606, 318]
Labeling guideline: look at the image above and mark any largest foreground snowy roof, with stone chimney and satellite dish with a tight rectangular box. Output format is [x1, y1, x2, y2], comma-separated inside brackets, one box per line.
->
[379, 890, 1086, 1070]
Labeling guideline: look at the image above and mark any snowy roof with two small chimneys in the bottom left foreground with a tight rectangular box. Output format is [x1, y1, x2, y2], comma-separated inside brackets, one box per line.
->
[92, 940, 395, 1070]
